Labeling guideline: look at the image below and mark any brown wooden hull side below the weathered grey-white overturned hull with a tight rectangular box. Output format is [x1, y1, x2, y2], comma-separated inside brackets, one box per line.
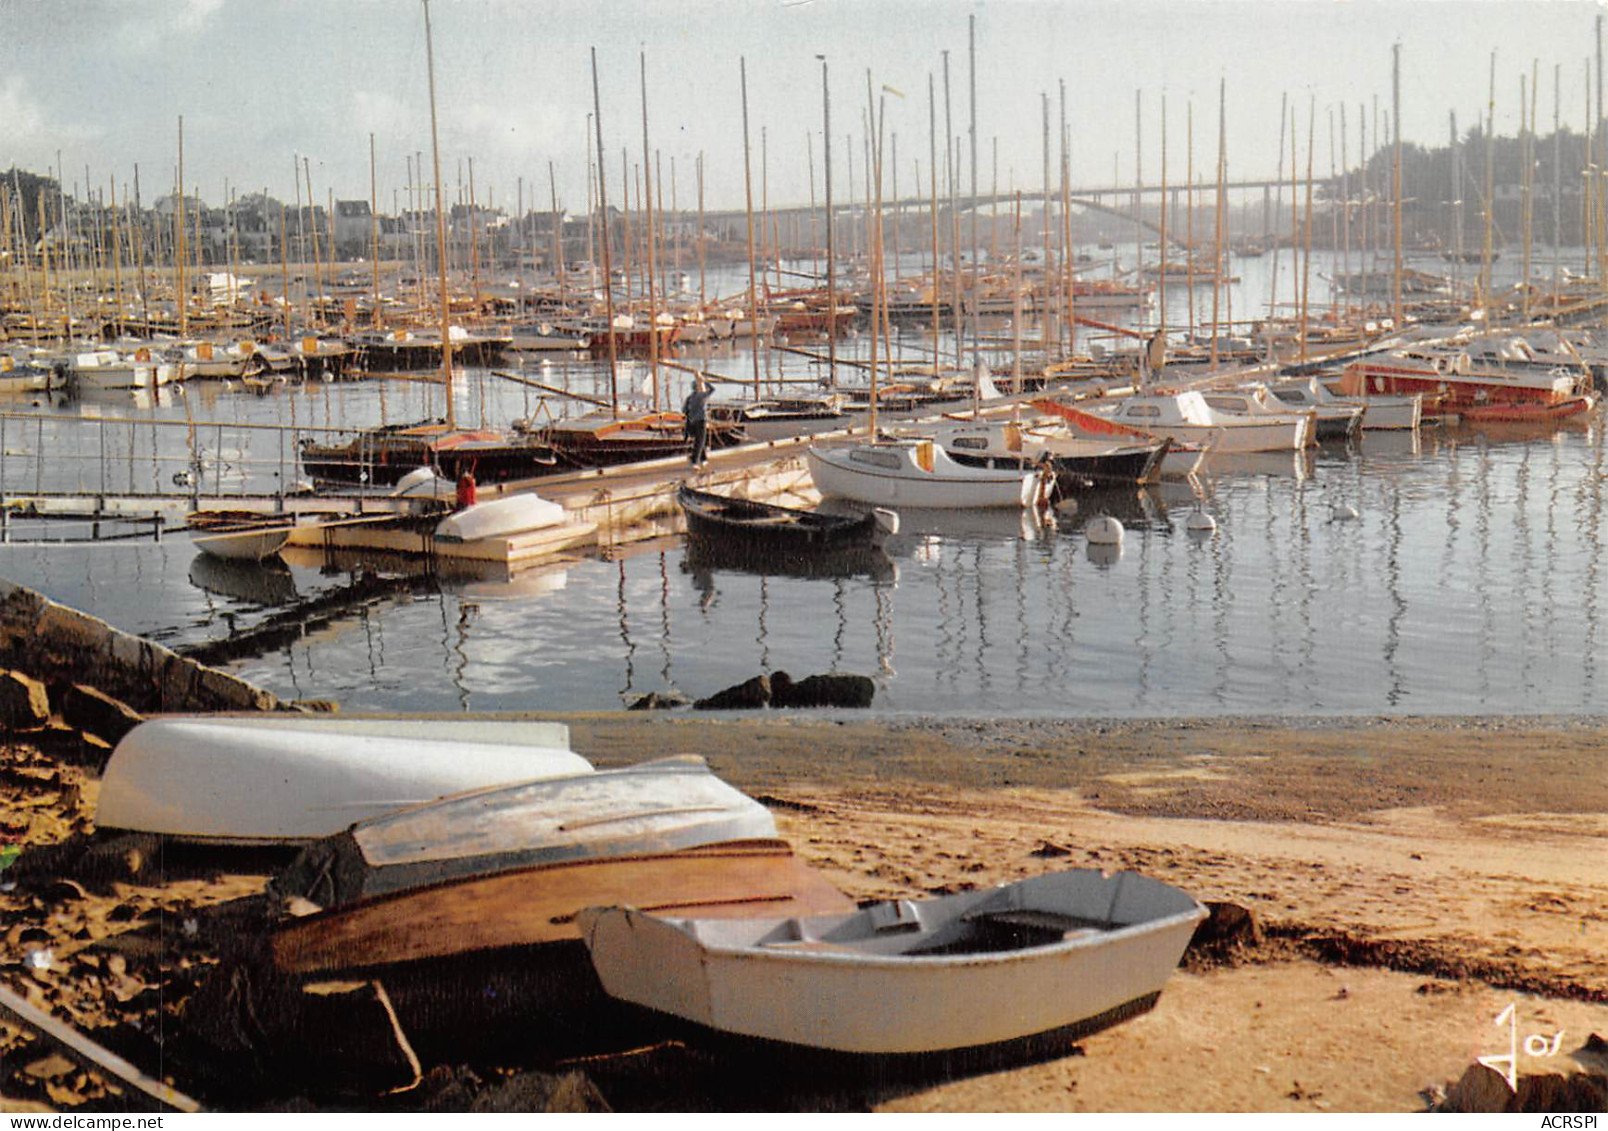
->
[272, 840, 854, 973]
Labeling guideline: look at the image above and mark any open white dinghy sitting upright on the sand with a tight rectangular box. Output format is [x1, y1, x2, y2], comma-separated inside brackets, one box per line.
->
[580, 869, 1206, 1055]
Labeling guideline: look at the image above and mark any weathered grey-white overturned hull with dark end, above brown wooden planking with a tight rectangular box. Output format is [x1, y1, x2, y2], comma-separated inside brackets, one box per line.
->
[273, 755, 777, 907]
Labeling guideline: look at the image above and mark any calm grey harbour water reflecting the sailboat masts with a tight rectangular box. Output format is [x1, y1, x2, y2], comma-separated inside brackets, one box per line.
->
[0, 249, 1608, 716]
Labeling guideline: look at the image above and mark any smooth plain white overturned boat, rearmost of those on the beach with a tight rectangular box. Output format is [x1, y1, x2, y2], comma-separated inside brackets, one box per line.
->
[95, 716, 592, 843]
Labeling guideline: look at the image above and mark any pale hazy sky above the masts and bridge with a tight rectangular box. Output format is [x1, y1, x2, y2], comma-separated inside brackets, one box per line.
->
[0, 0, 1608, 212]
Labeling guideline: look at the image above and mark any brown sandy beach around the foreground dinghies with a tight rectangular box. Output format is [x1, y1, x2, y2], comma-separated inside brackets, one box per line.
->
[0, 714, 1608, 1112]
